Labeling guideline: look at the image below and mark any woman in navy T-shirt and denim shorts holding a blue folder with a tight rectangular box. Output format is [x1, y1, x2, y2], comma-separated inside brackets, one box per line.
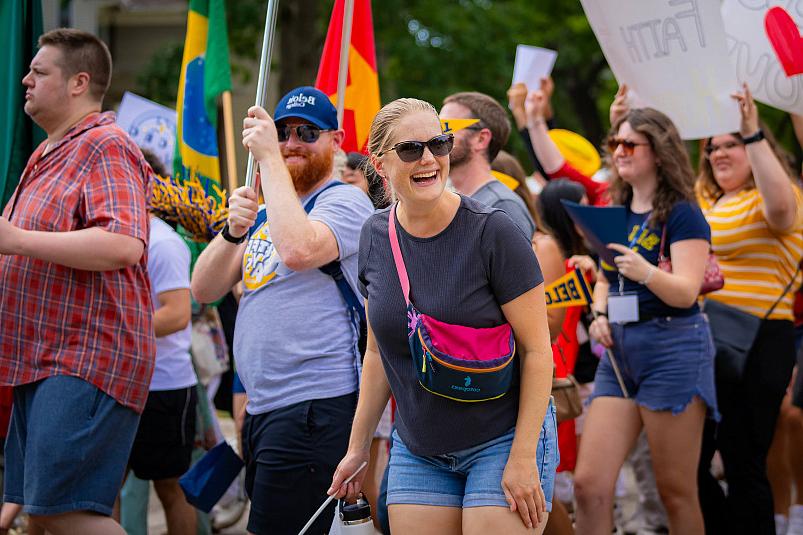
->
[575, 108, 716, 535]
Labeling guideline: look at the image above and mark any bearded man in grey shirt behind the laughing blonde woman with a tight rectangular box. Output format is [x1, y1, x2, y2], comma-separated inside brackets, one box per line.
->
[440, 92, 535, 238]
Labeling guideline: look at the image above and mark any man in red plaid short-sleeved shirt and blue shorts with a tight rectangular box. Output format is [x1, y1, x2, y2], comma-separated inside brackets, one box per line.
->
[0, 29, 155, 535]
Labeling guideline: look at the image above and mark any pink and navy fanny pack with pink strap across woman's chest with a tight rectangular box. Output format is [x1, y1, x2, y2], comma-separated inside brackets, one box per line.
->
[388, 205, 516, 402]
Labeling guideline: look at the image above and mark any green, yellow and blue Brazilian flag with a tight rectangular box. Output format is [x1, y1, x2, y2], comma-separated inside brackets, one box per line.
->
[173, 0, 231, 191]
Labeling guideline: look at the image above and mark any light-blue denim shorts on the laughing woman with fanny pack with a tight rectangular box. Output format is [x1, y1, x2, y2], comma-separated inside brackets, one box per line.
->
[387, 401, 560, 511]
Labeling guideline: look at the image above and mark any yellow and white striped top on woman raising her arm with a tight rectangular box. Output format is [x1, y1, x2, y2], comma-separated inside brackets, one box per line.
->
[698, 186, 803, 320]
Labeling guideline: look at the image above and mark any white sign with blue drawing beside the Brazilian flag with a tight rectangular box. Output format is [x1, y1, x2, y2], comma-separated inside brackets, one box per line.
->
[117, 91, 176, 175]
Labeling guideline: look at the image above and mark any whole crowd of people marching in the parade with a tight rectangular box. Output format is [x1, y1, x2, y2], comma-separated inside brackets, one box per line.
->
[0, 29, 803, 535]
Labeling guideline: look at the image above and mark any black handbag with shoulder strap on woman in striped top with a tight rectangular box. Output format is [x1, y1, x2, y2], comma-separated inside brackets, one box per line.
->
[704, 266, 800, 384]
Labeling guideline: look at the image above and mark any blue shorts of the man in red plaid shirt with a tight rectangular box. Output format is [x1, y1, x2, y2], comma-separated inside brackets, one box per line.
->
[3, 375, 139, 515]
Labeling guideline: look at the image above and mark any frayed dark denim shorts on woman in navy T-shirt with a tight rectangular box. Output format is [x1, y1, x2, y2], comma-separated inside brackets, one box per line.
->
[591, 314, 719, 420]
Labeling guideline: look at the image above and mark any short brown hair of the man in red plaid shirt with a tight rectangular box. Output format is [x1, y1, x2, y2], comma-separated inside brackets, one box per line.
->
[39, 28, 112, 101]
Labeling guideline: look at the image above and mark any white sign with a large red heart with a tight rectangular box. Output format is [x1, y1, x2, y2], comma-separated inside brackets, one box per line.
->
[722, 0, 803, 114]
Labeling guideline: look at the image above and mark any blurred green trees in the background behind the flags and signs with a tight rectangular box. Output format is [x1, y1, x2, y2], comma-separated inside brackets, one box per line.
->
[139, 0, 801, 172]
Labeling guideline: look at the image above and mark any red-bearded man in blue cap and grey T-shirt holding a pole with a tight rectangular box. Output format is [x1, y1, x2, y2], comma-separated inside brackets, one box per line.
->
[191, 87, 373, 535]
